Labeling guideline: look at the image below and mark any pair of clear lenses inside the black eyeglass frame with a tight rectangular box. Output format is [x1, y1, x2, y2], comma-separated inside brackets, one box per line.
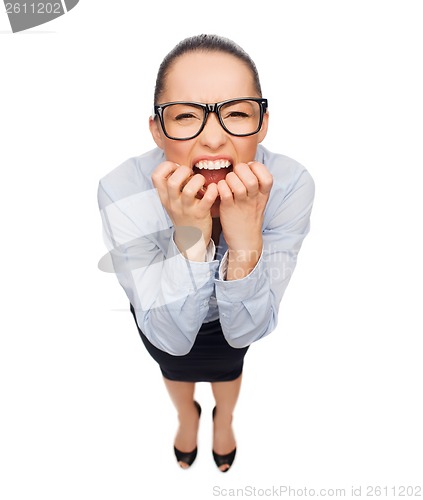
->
[163, 99, 261, 139]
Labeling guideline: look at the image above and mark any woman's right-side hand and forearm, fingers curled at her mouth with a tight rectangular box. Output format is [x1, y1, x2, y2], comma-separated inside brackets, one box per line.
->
[217, 162, 273, 279]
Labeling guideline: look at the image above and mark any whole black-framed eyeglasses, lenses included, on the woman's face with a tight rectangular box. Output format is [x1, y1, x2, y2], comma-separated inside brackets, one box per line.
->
[154, 97, 267, 141]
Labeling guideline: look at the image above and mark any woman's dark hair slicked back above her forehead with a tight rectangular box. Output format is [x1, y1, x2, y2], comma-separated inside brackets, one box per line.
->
[154, 35, 262, 105]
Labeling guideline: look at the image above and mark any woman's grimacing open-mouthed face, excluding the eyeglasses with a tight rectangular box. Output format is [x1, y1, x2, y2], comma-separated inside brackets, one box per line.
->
[150, 52, 268, 215]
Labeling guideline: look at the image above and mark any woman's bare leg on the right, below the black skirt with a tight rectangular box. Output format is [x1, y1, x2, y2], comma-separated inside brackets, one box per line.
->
[212, 375, 242, 471]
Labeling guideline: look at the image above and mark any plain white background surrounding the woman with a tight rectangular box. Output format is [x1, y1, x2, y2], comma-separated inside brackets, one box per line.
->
[0, 0, 423, 500]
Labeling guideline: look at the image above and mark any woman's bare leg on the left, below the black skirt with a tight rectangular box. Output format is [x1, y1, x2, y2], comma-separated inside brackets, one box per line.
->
[163, 378, 199, 469]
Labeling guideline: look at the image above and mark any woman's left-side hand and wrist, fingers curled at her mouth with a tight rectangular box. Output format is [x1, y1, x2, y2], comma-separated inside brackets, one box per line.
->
[151, 161, 218, 261]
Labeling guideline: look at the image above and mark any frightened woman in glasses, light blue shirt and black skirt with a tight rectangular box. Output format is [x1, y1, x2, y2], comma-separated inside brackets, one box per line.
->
[98, 35, 314, 472]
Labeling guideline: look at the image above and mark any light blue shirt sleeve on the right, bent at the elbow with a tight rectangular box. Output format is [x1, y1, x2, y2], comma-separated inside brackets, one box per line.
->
[216, 170, 314, 348]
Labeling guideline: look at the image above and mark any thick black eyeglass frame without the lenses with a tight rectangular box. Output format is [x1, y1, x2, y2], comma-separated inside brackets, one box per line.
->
[153, 97, 268, 141]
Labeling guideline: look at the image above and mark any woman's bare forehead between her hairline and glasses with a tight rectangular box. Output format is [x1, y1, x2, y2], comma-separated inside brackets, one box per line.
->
[161, 51, 259, 103]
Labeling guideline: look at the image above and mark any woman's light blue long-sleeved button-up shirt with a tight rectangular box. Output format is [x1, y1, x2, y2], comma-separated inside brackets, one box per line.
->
[98, 145, 314, 356]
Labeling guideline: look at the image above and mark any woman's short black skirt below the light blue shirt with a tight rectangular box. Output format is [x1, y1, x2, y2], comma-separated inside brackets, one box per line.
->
[131, 304, 249, 382]
